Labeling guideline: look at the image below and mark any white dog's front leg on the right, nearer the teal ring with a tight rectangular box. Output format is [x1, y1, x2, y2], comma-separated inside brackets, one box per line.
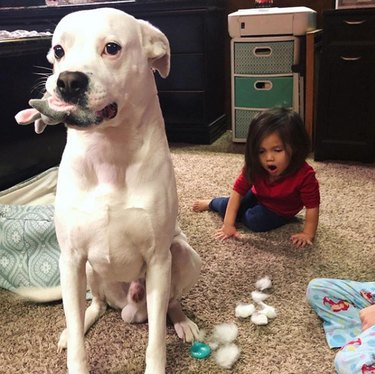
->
[145, 250, 172, 374]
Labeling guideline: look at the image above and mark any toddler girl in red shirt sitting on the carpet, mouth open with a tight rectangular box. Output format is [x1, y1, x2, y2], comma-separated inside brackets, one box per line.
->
[193, 108, 320, 247]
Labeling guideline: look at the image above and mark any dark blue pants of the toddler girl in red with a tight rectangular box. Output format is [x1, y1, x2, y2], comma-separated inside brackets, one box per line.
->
[209, 191, 291, 232]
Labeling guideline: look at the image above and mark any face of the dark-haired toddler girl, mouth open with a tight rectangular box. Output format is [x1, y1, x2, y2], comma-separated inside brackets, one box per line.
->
[259, 132, 290, 181]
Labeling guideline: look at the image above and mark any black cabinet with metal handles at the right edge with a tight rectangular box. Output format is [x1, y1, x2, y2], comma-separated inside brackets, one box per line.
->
[315, 8, 375, 162]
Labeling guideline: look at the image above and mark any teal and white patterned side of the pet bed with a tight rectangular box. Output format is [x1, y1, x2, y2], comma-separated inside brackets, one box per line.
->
[0, 205, 60, 290]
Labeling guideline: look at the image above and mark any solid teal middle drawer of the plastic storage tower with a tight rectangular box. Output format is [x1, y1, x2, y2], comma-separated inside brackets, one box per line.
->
[234, 76, 293, 108]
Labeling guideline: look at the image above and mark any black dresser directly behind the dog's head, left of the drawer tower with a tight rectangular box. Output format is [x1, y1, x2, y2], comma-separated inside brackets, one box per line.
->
[0, 0, 227, 143]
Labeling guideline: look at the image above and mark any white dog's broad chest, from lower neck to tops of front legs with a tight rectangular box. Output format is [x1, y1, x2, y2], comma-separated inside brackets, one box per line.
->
[56, 132, 177, 281]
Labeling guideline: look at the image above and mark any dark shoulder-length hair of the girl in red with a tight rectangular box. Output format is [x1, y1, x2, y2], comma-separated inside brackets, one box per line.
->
[243, 108, 310, 183]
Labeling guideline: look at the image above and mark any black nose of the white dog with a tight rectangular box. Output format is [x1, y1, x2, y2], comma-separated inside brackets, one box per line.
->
[57, 71, 89, 104]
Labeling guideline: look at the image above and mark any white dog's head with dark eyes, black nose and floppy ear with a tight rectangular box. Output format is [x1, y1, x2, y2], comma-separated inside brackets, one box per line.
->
[46, 8, 170, 128]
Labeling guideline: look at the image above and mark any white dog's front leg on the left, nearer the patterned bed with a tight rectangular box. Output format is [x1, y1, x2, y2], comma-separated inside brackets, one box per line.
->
[60, 252, 89, 374]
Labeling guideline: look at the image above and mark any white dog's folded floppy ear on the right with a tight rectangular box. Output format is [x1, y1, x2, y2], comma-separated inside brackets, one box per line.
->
[138, 20, 171, 78]
